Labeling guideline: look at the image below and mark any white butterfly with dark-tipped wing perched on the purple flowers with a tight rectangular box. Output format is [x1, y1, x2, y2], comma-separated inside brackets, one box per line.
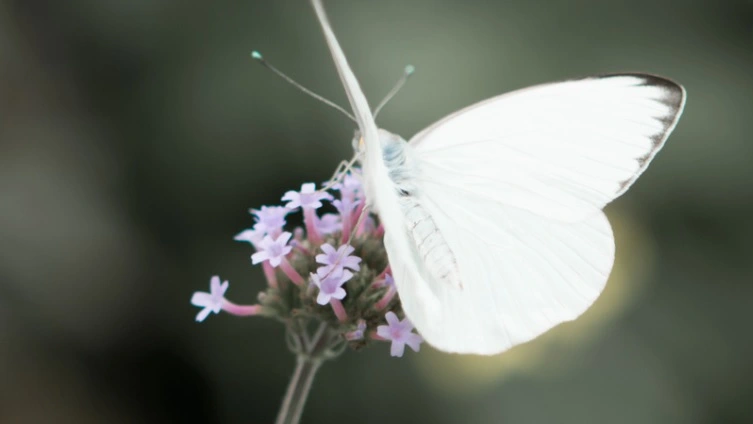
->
[312, 0, 685, 354]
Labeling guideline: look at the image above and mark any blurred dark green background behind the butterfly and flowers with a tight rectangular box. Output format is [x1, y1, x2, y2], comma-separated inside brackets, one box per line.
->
[0, 0, 753, 424]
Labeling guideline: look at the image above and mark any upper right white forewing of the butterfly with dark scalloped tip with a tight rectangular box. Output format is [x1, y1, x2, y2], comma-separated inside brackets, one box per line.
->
[410, 74, 685, 221]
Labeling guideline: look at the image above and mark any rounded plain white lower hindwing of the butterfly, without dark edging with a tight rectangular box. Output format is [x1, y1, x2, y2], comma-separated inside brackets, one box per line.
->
[396, 194, 614, 354]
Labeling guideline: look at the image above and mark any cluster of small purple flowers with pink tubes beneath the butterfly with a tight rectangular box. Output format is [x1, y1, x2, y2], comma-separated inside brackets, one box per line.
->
[191, 169, 422, 356]
